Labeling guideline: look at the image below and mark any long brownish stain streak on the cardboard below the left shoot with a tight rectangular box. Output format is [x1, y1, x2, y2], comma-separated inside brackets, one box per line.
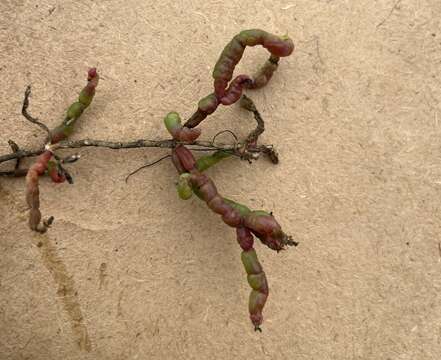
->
[39, 237, 92, 352]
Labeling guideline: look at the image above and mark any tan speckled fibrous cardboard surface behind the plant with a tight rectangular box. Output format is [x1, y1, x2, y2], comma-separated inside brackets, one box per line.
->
[0, 0, 441, 360]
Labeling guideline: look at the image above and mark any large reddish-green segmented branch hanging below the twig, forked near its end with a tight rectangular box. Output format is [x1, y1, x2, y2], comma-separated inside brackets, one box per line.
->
[168, 135, 293, 330]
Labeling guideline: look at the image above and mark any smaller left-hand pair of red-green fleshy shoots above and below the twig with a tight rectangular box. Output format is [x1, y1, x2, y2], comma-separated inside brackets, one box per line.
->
[26, 68, 99, 233]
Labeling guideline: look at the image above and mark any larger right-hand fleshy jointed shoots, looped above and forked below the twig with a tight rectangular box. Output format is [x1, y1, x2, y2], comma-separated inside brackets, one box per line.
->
[164, 29, 297, 331]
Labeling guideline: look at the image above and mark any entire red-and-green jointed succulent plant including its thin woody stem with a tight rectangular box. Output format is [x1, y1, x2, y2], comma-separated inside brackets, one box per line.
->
[0, 29, 297, 330]
